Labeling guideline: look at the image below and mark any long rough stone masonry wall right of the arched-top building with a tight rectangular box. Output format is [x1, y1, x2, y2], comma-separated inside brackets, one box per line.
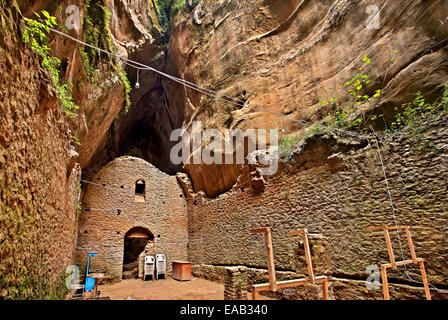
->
[189, 116, 448, 298]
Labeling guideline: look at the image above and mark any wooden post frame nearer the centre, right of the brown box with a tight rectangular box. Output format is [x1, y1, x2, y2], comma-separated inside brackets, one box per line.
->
[250, 228, 330, 300]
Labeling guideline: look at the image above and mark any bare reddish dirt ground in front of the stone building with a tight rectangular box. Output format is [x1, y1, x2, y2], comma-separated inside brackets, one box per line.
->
[98, 278, 268, 300]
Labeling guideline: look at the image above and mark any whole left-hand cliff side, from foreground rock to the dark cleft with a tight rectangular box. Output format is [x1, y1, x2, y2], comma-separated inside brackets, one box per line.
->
[0, 0, 164, 298]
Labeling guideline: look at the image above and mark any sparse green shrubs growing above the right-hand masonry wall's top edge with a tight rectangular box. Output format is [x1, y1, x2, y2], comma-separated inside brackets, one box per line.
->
[279, 46, 448, 158]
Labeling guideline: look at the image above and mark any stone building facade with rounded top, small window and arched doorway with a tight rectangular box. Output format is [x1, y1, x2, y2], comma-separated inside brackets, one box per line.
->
[76, 156, 188, 279]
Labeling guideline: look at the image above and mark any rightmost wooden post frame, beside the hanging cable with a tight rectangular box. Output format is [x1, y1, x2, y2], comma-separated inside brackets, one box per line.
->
[367, 226, 431, 300]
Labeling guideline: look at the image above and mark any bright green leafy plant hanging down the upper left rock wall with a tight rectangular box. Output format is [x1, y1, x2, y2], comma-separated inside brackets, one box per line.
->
[22, 11, 79, 118]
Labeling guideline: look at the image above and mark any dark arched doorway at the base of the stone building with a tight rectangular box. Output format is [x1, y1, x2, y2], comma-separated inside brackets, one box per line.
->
[123, 227, 154, 279]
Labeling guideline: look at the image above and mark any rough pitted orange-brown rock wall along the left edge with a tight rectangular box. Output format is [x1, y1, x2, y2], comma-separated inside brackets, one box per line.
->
[0, 3, 80, 299]
